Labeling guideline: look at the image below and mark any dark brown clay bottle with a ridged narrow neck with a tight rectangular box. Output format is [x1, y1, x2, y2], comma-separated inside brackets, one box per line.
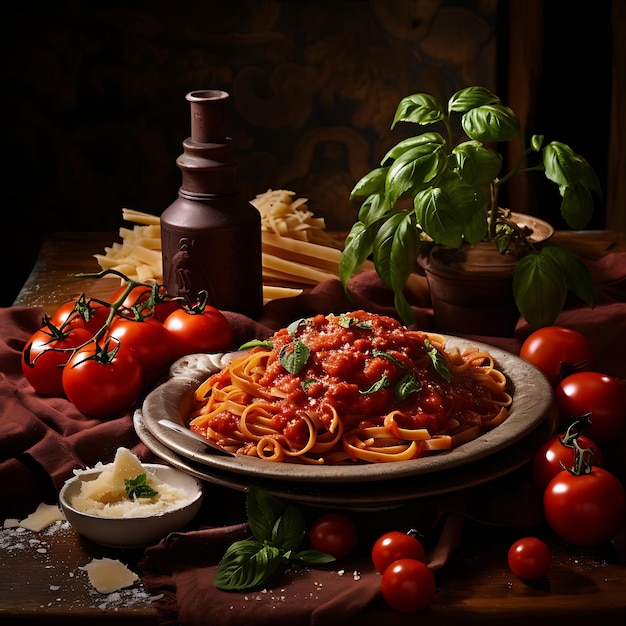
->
[161, 90, 263, 318]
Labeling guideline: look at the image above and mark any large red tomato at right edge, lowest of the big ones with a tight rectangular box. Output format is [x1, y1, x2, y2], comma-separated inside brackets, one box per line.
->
[543, 467, 626, 547]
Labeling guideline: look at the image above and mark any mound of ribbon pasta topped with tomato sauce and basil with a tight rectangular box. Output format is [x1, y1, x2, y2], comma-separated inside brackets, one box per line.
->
[189, 311, 512, 464]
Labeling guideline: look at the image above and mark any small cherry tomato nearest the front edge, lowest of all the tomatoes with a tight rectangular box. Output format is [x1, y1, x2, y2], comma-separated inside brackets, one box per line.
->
[380, 559, 437, 613]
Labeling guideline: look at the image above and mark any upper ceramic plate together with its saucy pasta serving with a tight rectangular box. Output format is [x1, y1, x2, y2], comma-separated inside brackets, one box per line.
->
[141, 311, 552, 483]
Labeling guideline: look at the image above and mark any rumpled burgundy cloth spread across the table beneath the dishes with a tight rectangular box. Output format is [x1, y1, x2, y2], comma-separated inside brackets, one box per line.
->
[0, 253, 626, 626]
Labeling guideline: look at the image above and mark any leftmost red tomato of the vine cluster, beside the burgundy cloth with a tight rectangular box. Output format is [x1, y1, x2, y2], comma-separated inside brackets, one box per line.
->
[22, 324, 93, 398]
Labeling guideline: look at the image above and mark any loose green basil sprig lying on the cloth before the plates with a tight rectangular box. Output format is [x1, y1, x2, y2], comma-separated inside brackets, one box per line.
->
[215, 486, 335, 591]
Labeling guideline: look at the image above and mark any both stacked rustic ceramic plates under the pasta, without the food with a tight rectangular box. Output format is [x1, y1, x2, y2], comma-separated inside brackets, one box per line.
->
[134, 336, 554, 509]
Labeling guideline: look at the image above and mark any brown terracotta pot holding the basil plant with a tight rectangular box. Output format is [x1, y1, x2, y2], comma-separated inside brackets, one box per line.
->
[418, 215, 554, 337]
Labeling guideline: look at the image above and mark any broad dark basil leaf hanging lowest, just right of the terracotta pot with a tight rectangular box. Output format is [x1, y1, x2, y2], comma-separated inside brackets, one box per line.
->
[513, 253, 567, 328]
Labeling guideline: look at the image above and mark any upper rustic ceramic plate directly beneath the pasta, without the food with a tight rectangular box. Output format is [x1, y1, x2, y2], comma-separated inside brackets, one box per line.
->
[142, 336, 552, 483]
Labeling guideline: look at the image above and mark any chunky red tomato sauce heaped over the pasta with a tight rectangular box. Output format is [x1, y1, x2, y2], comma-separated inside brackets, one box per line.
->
[251, 311, 485, 446]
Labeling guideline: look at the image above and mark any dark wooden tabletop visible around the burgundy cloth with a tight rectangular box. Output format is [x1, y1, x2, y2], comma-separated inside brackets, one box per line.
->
[0, 227, 626, 626]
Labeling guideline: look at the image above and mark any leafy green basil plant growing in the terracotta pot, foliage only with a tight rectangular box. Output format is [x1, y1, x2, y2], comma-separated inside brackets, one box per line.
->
[339, 87, 600, 328]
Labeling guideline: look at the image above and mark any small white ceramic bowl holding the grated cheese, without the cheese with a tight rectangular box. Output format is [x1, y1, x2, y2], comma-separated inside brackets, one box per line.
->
[59, 463, 204, 548]
